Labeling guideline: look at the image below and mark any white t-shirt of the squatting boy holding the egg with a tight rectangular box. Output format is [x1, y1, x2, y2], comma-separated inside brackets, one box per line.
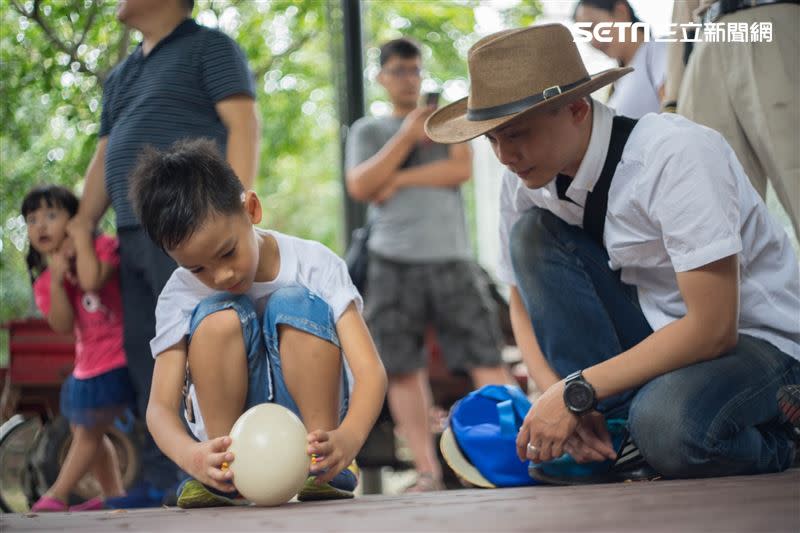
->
[150, 230, 363, 357]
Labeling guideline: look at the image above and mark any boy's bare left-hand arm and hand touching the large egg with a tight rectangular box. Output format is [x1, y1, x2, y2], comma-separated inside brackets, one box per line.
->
[147, 340, 234, 491]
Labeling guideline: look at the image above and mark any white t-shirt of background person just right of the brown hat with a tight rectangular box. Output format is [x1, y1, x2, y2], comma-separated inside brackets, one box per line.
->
[608, 41, 667, 118]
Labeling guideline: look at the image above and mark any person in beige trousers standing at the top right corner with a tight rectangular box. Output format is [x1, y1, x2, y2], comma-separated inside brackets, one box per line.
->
[664, 0, 800, 239]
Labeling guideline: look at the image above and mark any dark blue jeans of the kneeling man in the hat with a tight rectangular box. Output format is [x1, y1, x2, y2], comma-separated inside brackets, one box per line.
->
[510, 208, 800, 477]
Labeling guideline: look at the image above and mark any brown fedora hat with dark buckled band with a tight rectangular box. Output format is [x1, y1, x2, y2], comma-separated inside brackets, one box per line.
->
[425, 24, 633, 144]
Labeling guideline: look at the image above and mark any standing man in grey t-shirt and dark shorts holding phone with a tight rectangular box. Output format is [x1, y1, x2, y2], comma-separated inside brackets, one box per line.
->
[346, 39, 513, 492]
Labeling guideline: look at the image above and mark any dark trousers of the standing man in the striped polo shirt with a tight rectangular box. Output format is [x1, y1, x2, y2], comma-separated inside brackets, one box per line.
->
[117, 228, 179, 489]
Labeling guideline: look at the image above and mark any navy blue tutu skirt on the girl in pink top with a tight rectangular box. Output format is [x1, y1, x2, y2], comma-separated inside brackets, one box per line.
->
[61, 367, 135, 427]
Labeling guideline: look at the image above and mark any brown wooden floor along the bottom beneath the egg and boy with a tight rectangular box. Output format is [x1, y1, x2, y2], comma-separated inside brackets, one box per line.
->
[0, 469, 800, 533]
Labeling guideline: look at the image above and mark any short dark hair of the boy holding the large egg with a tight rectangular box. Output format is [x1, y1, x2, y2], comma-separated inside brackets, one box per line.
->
[129, 139, 244, 250]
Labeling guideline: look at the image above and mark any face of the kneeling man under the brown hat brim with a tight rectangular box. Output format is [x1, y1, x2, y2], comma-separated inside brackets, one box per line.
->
[486, 99, 591, 189]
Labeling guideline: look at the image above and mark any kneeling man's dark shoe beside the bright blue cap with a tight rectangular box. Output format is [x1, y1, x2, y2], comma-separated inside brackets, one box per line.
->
[528, 419, 661, 485]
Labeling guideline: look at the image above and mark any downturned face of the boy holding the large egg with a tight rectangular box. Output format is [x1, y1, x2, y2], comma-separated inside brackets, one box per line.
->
[167, 191, 261, 294]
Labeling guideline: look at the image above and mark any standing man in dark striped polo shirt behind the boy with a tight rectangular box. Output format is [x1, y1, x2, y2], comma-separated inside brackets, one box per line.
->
[72, 0, 260, 498]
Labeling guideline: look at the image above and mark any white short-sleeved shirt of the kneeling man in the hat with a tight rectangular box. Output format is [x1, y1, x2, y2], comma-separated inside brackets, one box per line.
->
[497, 102, 800, 359]
